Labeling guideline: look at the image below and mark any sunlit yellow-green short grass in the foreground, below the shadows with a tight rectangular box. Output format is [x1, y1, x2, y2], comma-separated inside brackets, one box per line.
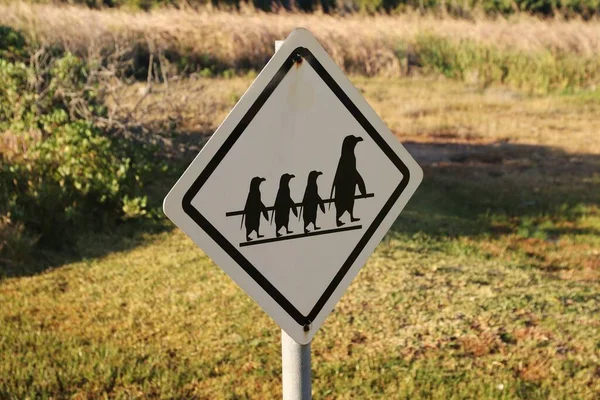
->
[0, 171, 600, 399]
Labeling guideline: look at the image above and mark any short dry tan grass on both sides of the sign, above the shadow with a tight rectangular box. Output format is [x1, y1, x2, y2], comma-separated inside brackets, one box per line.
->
[115, 76, 600, 155]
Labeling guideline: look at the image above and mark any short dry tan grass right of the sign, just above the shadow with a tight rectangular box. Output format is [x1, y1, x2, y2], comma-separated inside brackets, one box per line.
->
[354, 77, 600, 154]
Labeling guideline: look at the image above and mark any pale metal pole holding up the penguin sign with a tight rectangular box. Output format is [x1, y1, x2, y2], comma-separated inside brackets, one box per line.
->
[275, 40, 312, 400]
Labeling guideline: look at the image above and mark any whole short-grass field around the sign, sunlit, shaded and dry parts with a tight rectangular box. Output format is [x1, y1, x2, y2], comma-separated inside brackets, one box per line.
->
[0, 76, 600, 399]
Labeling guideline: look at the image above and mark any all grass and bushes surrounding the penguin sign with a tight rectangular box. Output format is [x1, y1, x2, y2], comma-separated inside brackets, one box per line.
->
[0, 0, 600, 399]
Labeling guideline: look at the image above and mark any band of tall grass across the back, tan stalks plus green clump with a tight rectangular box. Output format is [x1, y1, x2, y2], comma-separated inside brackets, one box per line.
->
[0, 2, 600, 93]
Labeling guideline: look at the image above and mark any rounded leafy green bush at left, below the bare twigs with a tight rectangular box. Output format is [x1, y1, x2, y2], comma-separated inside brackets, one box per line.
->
[0, 121, 159, 245]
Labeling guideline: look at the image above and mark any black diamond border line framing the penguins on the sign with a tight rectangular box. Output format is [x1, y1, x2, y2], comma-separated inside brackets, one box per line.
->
[182, 47, 410, 327]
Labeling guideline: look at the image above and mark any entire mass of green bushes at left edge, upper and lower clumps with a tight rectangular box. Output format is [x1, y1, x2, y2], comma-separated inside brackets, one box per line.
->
[0, 27, 160, 248]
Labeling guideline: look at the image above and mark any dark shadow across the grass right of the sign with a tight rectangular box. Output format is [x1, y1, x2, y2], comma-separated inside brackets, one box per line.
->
[392, 142, 600, 237]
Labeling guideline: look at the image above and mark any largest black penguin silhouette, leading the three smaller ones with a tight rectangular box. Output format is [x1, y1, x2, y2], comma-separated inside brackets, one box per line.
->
[329, 135, 367, 226]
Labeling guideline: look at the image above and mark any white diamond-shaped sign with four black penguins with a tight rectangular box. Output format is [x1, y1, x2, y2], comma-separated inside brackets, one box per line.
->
[164, 29, 423, 344]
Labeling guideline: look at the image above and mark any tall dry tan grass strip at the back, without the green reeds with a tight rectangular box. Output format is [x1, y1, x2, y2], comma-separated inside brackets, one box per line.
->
[0, 2, 600, 75]
